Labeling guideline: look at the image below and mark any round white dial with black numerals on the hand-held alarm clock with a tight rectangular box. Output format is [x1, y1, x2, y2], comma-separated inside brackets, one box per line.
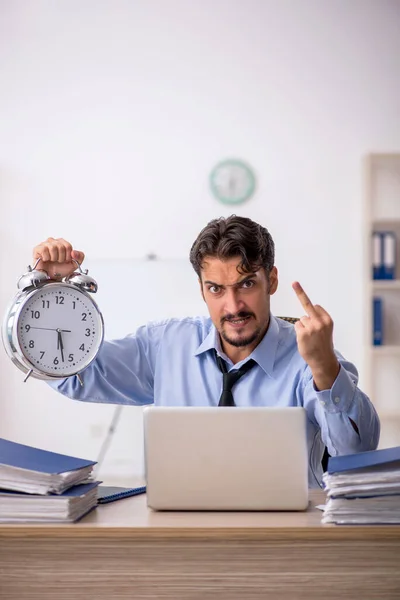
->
[15, 284, 103, 377]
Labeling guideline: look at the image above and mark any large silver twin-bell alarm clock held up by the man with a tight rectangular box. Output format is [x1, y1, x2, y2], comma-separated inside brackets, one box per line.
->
[2, 259, 104, 385]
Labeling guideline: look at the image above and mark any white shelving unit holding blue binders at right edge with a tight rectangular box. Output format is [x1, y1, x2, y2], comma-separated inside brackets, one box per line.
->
[364, 153, 400, 448]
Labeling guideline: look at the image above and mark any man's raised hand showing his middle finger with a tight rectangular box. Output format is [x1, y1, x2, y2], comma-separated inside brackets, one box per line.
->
[292, 281, 340, 390]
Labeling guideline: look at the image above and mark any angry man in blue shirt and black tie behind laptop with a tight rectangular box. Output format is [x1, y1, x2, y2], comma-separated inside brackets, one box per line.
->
[33, 215, 380, 487]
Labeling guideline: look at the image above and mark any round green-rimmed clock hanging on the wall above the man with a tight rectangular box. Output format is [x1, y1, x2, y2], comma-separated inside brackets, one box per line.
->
[210, 159, 256, 204]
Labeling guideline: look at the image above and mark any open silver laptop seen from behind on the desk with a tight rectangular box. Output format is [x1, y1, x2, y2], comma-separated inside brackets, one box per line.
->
[144, 406, 308, 511]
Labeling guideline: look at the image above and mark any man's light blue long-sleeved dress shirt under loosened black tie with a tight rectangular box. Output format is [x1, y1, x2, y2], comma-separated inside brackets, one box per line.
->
[50, 315, 380, 487]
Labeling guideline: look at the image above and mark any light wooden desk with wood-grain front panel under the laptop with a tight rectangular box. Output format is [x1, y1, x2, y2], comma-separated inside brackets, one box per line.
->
[0, 492, 400, 600]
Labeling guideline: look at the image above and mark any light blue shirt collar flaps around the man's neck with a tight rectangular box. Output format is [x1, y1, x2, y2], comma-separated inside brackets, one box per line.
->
[194, 315, 279, 376]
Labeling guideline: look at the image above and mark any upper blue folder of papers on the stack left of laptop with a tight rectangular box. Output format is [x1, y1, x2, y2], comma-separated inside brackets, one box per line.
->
[0, 438, 96, 494]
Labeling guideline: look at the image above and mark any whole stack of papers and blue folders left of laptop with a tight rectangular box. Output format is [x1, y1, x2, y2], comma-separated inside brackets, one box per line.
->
[0, 438, 99, 523]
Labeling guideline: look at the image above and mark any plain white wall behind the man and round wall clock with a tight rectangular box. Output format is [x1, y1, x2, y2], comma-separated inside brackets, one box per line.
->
[0, 0, 400, 473]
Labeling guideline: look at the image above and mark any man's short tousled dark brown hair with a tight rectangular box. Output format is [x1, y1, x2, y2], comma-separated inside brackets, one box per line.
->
[190, 215, 275, 278]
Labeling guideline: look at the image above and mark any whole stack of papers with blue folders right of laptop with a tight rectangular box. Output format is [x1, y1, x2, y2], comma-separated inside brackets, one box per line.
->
[322, 446, 400, 525]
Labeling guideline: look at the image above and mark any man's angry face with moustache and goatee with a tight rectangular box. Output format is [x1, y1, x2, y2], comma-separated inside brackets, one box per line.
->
[200, 257, 278, 354]
